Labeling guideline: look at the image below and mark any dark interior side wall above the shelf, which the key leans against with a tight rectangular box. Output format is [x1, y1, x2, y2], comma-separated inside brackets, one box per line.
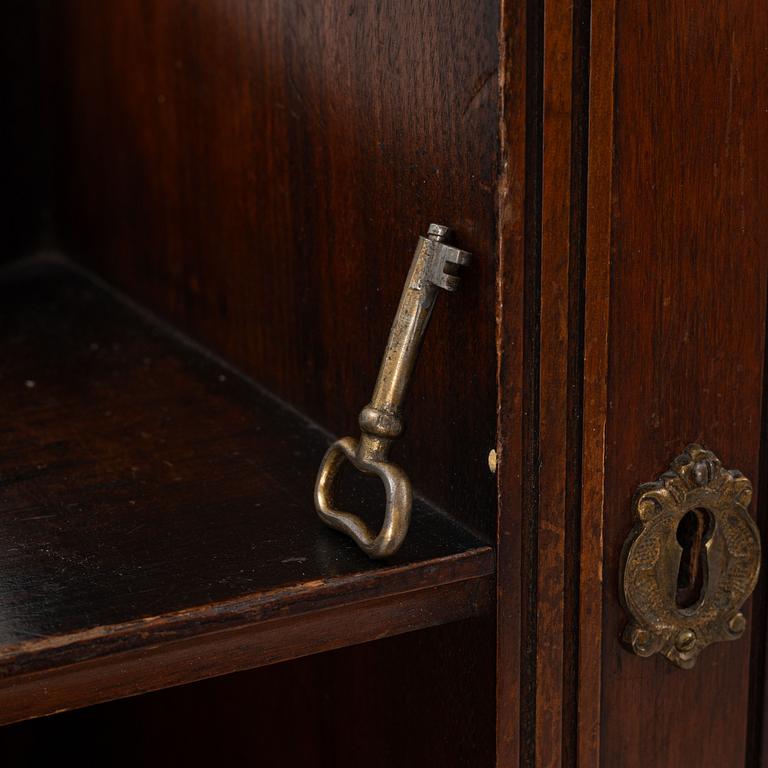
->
[43, 0, 498, 537]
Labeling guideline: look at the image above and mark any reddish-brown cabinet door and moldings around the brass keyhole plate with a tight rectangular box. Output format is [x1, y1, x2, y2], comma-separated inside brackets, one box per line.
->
[500, 0, 768, 768]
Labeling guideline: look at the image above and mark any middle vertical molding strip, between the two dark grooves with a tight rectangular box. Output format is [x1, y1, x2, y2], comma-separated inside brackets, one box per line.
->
[535, 0, 573, 768]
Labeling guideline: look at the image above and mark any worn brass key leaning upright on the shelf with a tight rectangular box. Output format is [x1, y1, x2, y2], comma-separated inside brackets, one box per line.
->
[315, 224, 470, 558]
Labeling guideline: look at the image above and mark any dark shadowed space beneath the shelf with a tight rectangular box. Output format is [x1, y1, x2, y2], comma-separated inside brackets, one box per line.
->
[0, 619, 493, 768]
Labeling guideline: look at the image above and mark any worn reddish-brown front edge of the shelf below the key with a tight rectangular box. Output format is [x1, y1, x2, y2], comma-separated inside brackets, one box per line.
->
[0, 578, 493, 728]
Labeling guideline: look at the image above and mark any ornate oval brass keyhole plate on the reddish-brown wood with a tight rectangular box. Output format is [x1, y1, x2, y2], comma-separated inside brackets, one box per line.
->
[619, 445, 760, 669]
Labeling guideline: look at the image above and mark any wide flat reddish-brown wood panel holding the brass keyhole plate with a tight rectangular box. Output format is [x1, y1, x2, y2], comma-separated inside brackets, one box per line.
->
[596, 0, 768, 768]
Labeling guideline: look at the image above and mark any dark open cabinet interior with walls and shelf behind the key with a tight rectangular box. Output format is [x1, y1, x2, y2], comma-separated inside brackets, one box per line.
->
[0, 0, 498, 766]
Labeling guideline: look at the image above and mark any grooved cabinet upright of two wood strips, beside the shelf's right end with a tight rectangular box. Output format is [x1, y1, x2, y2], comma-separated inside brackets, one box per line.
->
[498, 0, 590, 766]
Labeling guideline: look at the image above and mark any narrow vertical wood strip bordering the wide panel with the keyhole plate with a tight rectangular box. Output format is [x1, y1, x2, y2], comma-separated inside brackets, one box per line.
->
[577, 2, 615, 768]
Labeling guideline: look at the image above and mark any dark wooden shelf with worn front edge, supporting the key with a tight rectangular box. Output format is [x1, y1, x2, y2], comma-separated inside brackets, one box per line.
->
[0, 261, 494, 723]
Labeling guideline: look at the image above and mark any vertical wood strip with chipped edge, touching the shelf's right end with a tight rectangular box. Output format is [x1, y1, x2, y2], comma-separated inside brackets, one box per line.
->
[496, 0, 527, 768]
